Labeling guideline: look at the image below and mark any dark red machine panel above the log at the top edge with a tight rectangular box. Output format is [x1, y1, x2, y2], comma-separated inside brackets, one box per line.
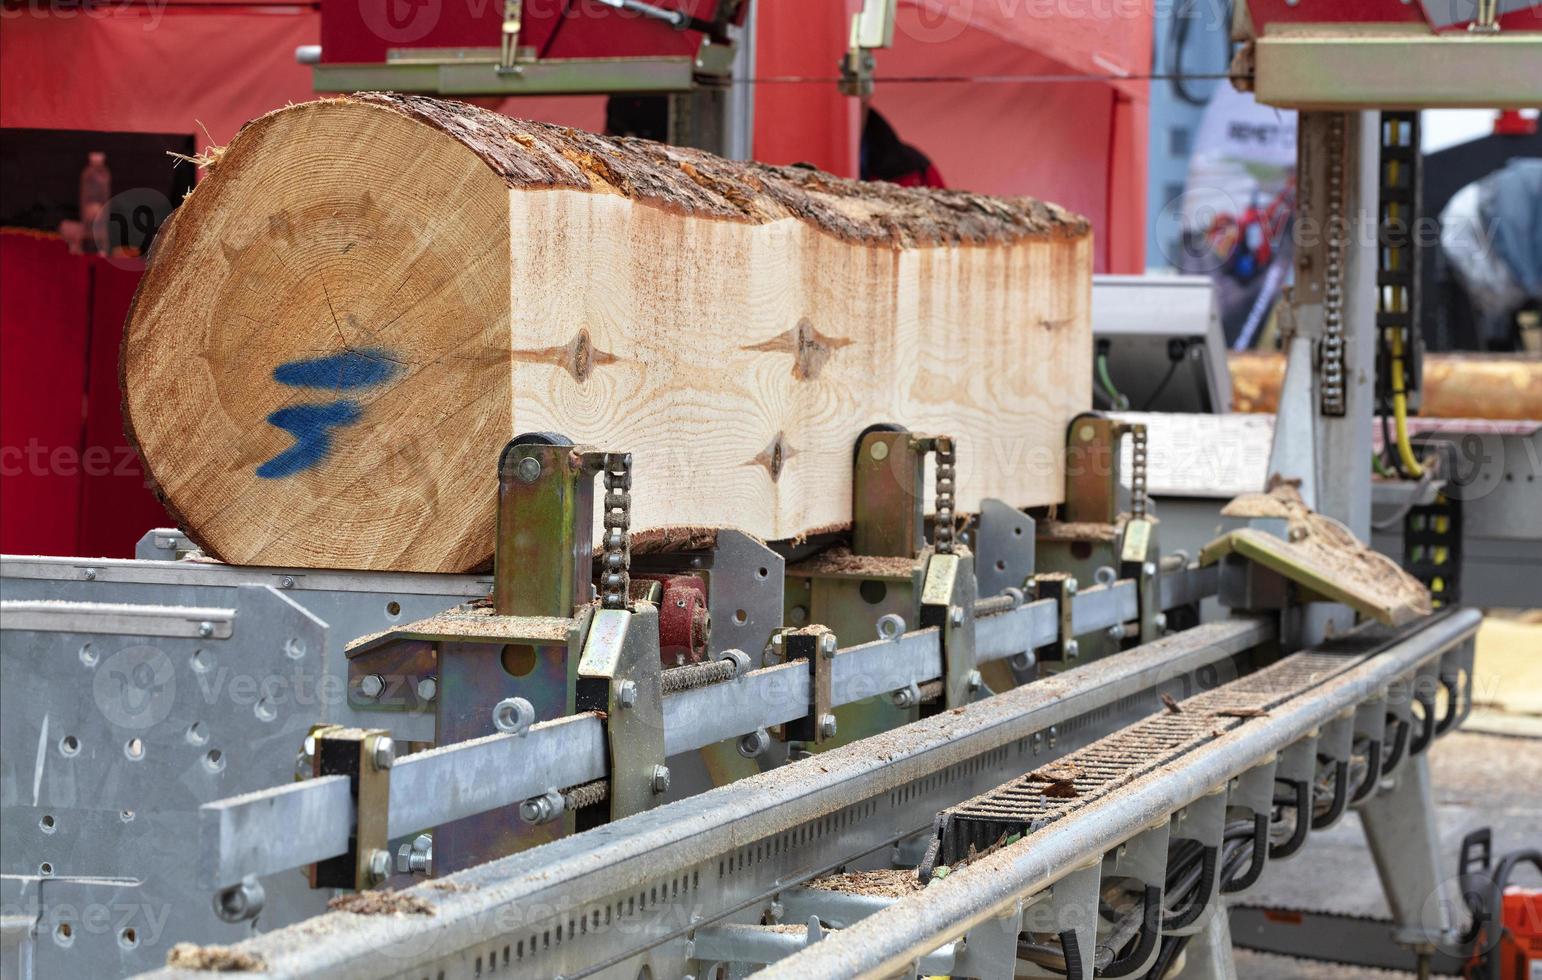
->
[321, 0, 733, 65]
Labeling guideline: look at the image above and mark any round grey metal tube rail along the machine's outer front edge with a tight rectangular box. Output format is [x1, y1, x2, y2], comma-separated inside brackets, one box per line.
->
[760, 609, 1482, 980]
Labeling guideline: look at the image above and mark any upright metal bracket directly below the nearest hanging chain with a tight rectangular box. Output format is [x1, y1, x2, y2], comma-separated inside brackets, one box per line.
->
[577, 602, 669, 831]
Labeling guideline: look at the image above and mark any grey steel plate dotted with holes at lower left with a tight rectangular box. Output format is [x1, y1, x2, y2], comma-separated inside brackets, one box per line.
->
[0, 586, 327, 977]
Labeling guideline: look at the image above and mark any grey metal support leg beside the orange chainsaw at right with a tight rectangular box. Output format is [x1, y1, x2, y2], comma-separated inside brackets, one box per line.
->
[1360, 755, 1453, 946]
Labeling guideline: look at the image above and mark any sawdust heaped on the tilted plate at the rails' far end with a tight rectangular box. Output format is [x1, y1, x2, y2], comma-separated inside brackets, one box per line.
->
[1221, 482, 1431, 615]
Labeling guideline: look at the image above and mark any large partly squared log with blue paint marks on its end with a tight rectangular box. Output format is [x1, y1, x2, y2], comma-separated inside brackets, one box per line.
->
[123, 94, 1092, 572]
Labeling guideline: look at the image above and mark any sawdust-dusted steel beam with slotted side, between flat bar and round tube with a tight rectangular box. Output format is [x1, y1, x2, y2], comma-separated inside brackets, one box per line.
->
[150, 619, 1274, 978]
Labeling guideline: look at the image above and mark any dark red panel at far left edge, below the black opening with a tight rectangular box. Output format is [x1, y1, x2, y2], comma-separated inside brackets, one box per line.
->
[0, 231, 91, 555]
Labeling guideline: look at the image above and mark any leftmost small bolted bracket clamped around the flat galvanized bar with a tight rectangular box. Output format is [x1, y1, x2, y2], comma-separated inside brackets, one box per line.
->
[310, 726, 396, 891]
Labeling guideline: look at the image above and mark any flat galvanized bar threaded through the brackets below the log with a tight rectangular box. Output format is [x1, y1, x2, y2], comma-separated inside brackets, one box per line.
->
[197, 567, 1215, 889]
